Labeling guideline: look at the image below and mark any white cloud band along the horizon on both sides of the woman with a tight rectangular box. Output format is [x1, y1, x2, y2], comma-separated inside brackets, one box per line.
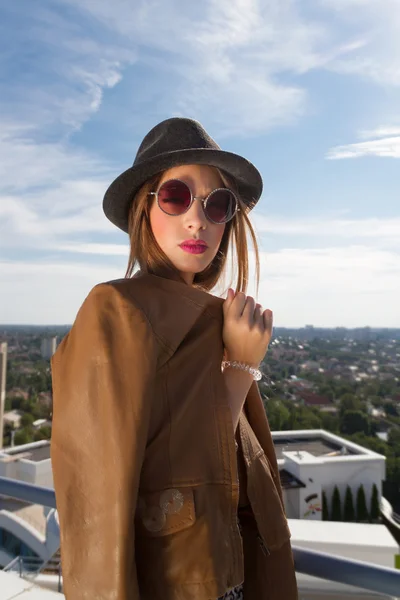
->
[0, 245, 400, 327]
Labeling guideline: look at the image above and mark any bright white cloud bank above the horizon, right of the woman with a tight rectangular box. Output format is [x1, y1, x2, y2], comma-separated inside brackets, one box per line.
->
[242, 245, 400, 327]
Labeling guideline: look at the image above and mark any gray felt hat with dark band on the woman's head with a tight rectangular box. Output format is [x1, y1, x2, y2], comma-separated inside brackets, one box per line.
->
[103, 117, 263, 233]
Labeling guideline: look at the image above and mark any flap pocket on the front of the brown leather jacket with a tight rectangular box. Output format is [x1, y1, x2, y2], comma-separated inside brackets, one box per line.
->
[135, 488, 196, 537]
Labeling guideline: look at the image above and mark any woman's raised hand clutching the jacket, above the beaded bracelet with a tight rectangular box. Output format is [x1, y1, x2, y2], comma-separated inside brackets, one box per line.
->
[222, 289, 273, 367]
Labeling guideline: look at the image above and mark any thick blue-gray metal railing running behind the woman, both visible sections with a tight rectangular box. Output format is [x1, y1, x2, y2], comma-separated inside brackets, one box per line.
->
[0, 477, 400, 598]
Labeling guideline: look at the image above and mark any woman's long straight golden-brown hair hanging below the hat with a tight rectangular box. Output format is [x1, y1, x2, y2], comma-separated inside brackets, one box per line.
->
[125, 169, 260, 293]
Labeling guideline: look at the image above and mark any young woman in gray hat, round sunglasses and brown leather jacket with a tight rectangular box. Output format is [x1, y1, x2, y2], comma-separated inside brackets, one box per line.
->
[51, 118, 297, 600]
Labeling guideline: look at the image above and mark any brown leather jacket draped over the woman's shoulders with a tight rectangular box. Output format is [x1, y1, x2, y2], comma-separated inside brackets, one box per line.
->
[51, 273, 297, 600]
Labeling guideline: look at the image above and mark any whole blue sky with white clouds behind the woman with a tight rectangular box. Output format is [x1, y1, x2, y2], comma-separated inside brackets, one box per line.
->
[0, 0, 400, 327]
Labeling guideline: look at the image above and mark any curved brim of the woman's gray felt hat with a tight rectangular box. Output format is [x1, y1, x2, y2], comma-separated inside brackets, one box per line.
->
[103, 148, 263, 233]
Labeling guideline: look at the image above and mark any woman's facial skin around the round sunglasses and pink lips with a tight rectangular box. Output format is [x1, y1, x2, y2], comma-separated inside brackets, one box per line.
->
[150, 165, 225, 285]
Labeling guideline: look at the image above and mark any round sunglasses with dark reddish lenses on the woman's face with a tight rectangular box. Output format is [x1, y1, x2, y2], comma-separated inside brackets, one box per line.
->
[149, 179, 240, 225]
